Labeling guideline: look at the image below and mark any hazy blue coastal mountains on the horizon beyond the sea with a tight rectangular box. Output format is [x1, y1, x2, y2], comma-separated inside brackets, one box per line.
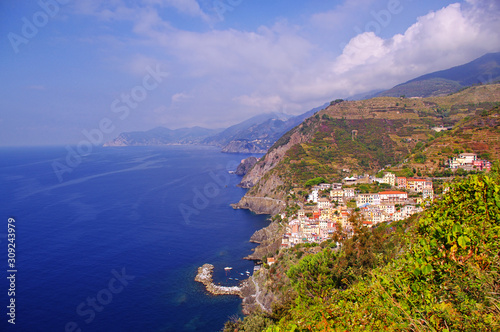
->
[104, 104, 328, 153]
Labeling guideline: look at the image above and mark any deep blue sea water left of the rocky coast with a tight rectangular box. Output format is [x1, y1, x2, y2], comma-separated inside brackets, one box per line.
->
[0, 146, 268, 332]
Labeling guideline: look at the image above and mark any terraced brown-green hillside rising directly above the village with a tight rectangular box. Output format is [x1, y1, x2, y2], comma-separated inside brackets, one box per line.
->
[238, 84, 500, 213]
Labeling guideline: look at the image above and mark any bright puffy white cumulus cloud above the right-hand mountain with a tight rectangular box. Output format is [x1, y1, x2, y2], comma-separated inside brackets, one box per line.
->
[333, 4, 500, 92]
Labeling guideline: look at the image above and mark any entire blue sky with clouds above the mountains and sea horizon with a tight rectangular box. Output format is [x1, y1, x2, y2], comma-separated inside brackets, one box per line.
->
[0, 0, 500, 146]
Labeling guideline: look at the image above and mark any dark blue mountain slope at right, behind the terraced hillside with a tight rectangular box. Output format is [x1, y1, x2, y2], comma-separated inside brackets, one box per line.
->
[372, 53, 500, 98]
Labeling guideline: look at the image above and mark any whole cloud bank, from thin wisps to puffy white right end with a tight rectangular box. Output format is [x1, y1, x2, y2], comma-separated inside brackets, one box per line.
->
[72, 0, 500, 126]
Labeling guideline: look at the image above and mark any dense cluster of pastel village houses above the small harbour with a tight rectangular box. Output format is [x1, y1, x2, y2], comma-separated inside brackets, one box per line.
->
[281, 173, 434, 248]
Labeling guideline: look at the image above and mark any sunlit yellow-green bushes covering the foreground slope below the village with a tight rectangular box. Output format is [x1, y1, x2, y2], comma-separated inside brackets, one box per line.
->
[226, 172, 500, 332]
